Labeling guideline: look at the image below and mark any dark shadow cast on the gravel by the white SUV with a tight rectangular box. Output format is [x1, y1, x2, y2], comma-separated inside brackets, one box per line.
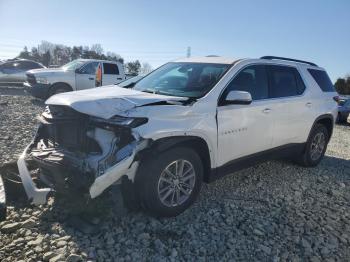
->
[0, 156, 350, 261]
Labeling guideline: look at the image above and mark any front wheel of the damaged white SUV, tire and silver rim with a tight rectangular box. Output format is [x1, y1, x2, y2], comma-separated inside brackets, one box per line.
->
[135, 147, 203, 217]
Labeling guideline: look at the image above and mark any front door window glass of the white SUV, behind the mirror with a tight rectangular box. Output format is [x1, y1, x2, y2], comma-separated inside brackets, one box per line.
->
[224, 65, 268, 100]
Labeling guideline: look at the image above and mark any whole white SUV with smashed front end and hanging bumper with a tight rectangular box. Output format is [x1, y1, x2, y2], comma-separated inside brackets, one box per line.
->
[18, 56, 337, 216]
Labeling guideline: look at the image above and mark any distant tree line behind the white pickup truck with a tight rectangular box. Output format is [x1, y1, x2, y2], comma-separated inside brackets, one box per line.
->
[17, 41, 152, 75]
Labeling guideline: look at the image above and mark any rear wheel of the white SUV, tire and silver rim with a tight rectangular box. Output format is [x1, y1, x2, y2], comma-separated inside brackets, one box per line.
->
[297, 124, 329, 167]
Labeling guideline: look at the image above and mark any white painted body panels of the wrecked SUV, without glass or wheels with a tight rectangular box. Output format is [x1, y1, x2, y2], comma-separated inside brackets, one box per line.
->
[17, 57, 337, 205]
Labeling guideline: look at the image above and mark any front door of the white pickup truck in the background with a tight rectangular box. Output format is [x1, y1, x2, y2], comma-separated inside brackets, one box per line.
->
[75, 62, 99, 90]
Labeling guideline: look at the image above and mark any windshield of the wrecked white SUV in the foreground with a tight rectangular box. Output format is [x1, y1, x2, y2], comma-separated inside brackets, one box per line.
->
[134, 63, 230, 98]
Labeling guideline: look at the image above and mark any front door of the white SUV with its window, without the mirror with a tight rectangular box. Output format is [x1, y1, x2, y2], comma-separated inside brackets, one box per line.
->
[217, 65, 273, 166]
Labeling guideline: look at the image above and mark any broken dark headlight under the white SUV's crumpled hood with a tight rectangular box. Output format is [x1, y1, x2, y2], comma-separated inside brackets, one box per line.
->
[90, 116, 148, 129]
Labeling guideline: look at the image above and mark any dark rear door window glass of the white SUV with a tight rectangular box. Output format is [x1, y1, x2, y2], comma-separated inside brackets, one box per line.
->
[268, 65, 305, 98]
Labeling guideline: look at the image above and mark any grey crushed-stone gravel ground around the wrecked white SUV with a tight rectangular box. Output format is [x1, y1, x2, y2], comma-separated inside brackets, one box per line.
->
[0, 91, 350, 262]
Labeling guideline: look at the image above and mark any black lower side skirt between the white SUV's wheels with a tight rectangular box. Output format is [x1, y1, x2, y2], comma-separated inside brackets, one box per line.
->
[206, 143, 305, 183]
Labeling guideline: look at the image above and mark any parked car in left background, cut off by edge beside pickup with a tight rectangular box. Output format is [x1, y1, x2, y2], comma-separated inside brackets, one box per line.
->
[0, 59, 45, 85]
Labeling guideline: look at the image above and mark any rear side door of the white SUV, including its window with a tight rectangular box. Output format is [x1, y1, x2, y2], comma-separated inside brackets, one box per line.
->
[267, 65, 313, 147]
